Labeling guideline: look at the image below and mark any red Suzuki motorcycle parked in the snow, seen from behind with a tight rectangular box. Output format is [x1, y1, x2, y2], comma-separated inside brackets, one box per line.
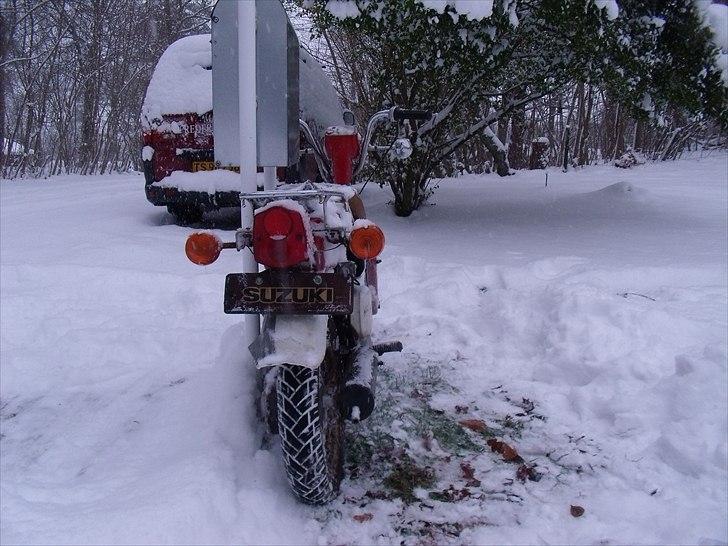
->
[185, 107, 431, 504]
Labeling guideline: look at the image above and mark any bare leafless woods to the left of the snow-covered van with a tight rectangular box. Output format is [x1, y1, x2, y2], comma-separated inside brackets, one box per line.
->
[0, 0, 211, 178]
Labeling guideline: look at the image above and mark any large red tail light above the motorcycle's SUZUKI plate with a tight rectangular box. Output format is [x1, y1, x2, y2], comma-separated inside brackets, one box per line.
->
[253, 206, 308, 268]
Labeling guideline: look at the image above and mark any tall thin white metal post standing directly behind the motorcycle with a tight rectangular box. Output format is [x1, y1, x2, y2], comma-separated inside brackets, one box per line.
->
[238, 0, 260, 344]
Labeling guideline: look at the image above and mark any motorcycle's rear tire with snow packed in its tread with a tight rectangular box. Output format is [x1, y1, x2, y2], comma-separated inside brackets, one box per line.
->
[276, 340, 344, 504]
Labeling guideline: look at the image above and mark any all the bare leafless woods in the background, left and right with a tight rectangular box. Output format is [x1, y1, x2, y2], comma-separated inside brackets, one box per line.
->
[0, 0, 726, 178]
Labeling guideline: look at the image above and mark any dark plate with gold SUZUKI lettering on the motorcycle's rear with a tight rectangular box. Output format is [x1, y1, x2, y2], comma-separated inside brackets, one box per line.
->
[224, 270, 352, 315]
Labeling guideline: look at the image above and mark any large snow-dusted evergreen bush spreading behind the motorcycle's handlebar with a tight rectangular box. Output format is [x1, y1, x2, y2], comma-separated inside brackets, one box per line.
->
[300, 0, 728, 216]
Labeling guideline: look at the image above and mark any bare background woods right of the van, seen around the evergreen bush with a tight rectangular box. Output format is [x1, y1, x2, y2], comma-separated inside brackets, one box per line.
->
[302, 20, 728, 173]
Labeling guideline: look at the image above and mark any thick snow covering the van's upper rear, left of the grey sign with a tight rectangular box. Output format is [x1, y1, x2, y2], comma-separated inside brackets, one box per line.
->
[142, 34, 212, 128]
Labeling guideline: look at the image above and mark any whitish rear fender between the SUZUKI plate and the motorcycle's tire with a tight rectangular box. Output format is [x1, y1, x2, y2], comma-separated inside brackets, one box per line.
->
[248, 315, 329, 369]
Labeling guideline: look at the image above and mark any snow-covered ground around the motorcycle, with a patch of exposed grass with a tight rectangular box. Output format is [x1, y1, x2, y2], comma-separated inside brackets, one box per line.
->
[0, 154, 728, 544]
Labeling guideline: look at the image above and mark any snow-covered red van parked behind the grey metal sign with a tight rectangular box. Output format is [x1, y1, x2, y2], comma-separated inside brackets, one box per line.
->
[141, 28, 343, 222]
